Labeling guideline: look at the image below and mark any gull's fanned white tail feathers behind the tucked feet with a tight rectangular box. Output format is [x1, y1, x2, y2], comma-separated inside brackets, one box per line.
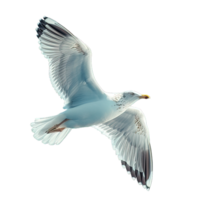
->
[28, 112, 72, 146]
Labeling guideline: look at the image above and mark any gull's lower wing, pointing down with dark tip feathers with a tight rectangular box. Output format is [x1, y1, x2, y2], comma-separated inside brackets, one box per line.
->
[92, 106, 153, 191]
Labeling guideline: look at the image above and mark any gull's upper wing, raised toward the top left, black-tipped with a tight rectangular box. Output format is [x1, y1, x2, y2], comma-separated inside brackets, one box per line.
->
[35, 16, 105, 108]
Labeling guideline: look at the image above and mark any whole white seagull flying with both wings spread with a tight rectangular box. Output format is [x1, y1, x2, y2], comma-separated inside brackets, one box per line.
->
[28, 16, 154, 192]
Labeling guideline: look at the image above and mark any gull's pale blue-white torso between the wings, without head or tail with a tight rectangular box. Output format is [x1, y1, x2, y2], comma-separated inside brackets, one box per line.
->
[47, 92, 141, 129]
